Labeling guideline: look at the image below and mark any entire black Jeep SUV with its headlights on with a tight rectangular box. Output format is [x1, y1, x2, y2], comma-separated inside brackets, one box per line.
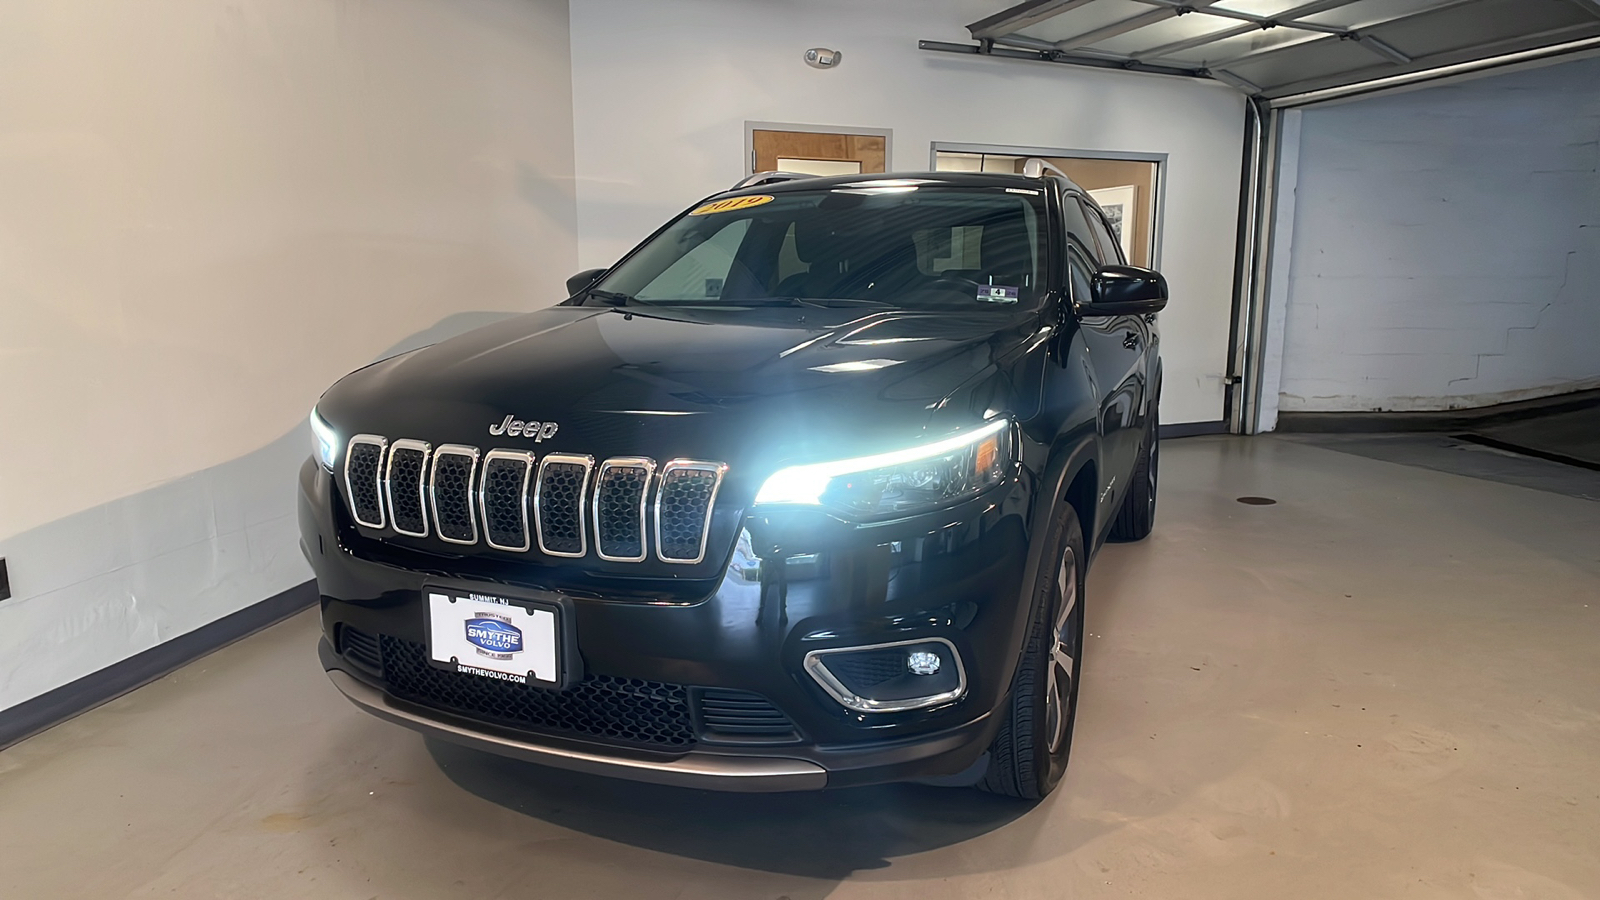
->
[299, 163, 1166, 798]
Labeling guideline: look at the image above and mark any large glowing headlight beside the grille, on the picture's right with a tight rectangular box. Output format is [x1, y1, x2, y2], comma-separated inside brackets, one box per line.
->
[755, 418, 1011, 516]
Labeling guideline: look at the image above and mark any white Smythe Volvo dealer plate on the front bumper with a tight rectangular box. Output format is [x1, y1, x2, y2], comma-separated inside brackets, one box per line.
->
[424, 586, 562, 687]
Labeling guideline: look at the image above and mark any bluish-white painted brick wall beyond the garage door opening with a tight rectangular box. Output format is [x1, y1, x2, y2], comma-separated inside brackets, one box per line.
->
[1274, 59, 1600, 412]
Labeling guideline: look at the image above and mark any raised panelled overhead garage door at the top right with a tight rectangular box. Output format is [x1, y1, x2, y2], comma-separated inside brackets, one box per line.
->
[966, 0, 1600, 99]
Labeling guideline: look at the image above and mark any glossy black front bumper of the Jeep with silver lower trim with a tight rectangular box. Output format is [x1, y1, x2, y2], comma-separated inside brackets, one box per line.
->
[301, 463, 1027, 791]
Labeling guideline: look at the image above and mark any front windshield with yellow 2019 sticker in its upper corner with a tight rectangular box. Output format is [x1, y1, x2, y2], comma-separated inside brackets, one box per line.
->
[590, 181, 1045, 309]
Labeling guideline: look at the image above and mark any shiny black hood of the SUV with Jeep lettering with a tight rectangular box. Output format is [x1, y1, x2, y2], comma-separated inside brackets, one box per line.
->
[318, 299, 1032, 477]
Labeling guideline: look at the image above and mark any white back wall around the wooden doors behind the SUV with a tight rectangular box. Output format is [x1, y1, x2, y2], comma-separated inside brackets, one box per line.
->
[571, 0, 1245, 423]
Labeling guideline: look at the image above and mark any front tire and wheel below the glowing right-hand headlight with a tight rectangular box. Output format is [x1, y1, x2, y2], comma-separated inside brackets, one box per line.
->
[976, 503, 1088, 801]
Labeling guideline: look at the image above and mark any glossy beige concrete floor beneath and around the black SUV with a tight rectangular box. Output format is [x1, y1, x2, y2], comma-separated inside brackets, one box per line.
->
[0, 437, 1600, 900]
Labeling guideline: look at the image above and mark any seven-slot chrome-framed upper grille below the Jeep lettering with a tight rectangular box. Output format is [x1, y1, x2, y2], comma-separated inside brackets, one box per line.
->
[344, 434, 728, 564]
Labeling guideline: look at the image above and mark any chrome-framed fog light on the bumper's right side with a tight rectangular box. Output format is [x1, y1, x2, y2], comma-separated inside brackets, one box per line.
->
[805, 637, 966, 713]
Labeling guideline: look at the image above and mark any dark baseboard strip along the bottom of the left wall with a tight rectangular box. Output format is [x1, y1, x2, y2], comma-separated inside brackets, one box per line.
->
[0, 581, 317, 749]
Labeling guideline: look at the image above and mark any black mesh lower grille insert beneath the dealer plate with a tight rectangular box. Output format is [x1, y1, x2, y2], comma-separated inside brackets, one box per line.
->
[381, 634, 694, 749]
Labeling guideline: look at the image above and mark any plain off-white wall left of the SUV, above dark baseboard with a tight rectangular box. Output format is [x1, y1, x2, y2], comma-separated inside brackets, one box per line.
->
[0, 0, 576, 709]
